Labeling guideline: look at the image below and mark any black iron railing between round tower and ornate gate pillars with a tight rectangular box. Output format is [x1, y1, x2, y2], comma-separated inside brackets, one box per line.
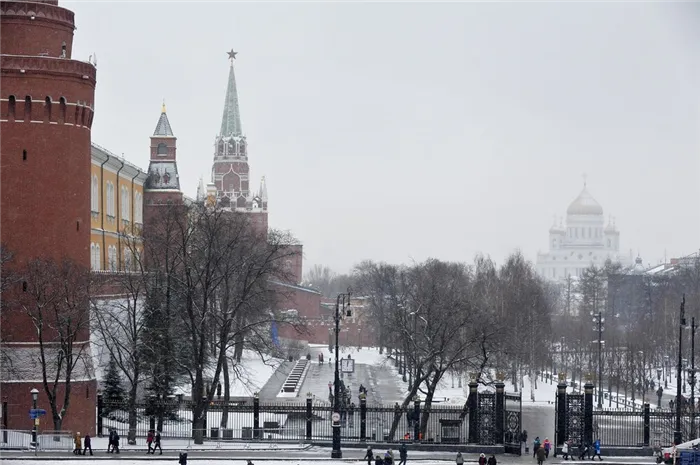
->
[97, 401, 469, 444]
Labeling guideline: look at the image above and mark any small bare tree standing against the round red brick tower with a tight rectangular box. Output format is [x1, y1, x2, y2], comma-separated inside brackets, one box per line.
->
[19, 259, 93, 431]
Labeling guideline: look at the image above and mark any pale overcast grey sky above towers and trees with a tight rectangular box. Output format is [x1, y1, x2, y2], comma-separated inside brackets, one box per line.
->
[67, 1, 700, 272]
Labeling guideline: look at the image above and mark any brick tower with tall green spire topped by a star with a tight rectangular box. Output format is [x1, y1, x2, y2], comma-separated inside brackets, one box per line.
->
[207, 50, 267, 232]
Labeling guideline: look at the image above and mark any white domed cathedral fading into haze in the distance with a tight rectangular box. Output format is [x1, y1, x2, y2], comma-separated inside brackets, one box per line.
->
[537, 182, 633, 281]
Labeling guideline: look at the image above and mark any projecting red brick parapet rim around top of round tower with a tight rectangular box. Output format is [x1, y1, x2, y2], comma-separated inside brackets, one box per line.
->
[0, 55, 97, 87]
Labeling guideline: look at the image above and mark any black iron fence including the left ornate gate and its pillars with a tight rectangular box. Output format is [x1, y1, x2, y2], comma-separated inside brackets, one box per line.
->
[97, 380, 520, 444]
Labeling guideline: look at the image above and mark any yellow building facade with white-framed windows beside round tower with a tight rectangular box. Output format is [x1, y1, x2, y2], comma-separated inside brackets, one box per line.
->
[90, 143, 148, 271]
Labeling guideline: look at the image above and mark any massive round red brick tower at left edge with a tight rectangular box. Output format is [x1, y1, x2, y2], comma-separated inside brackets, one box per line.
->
[0, 0, 96, 434]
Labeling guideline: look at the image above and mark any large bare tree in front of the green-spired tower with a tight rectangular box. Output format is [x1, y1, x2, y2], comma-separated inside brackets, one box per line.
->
[159, 204, 299, 443]
